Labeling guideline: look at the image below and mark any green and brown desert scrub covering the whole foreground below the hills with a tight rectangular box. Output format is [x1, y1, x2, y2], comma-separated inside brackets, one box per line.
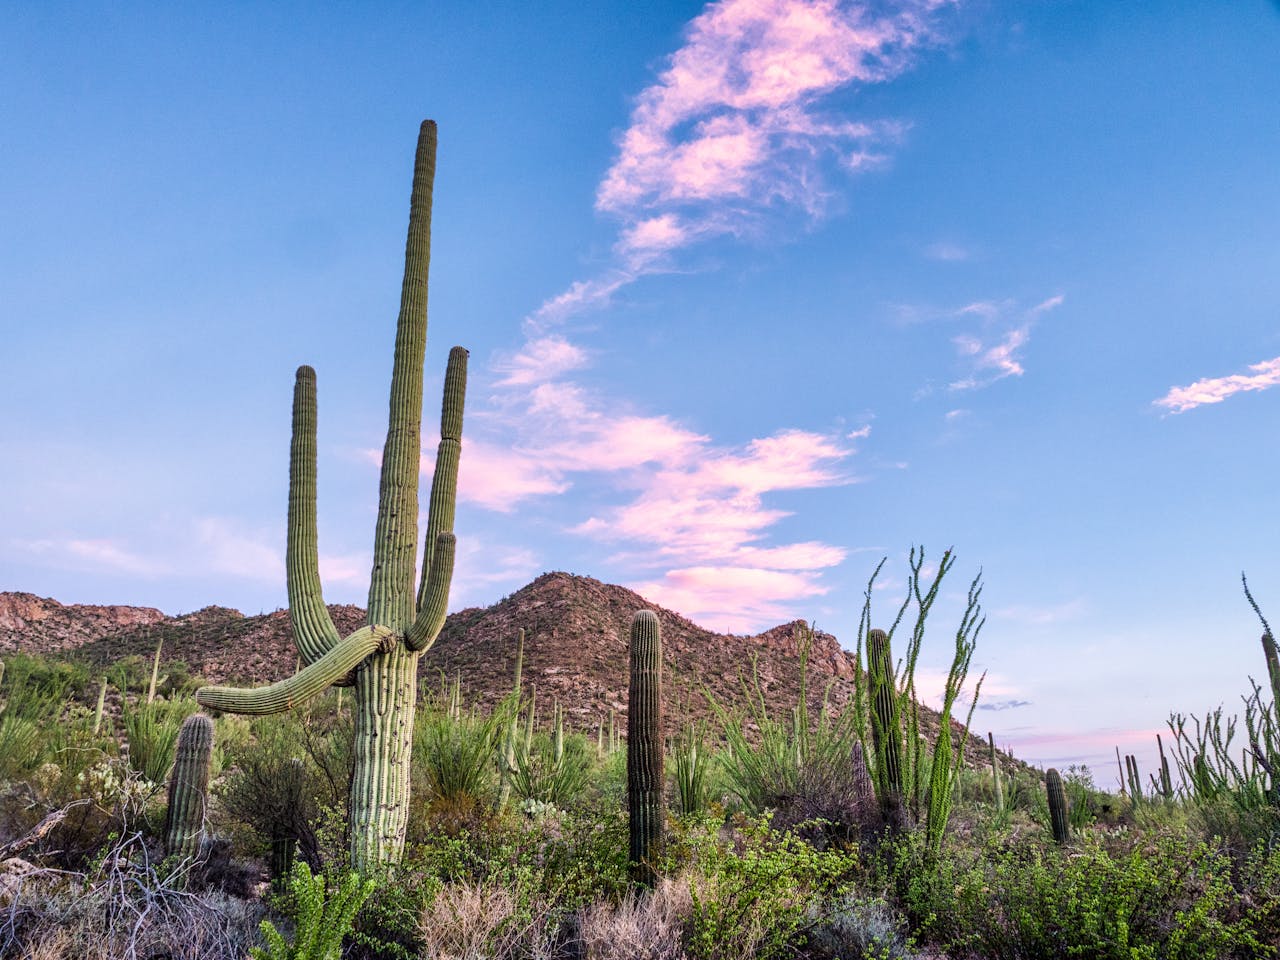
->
[0, 568, 1280, 960]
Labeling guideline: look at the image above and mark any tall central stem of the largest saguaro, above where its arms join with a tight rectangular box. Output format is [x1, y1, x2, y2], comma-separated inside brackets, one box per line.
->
[369, 120, 436, 631]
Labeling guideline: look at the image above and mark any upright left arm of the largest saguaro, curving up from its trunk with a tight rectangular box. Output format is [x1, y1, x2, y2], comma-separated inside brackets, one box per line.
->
[284, 366, 342, 663]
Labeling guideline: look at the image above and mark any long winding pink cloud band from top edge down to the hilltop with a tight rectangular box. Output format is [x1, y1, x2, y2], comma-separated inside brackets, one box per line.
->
[460, 0, 951, 628]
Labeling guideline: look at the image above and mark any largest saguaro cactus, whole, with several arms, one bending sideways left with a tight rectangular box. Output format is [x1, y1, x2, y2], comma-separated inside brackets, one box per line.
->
[197, 120, 467, 872]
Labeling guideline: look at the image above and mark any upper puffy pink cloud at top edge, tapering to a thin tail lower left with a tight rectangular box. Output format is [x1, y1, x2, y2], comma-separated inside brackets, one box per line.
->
[530, 0, 952, 329]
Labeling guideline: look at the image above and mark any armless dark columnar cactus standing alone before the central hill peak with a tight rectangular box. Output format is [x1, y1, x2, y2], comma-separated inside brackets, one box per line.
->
[627, 611, 666, 886]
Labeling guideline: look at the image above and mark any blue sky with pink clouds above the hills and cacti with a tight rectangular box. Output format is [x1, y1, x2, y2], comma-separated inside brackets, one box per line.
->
[0, 0, 1280, 783]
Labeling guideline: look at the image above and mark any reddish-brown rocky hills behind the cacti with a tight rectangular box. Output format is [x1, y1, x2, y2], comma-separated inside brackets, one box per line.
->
[0, 572, 988, 762]
